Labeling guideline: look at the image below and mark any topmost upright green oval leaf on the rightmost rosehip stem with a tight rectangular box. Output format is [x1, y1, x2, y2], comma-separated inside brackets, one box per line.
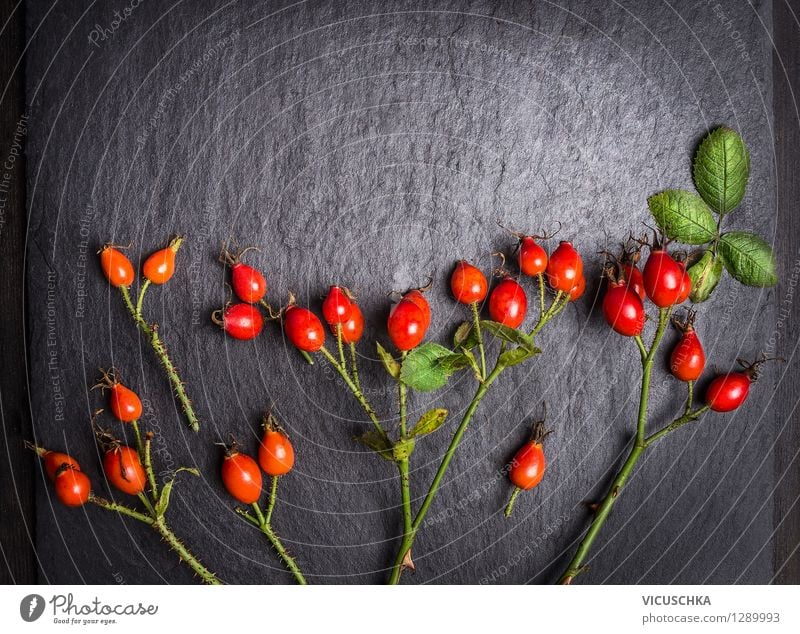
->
[692, 127, 750, 214]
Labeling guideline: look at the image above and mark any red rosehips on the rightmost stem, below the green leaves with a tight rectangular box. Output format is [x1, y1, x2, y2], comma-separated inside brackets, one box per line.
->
[603, 240, 765, 412]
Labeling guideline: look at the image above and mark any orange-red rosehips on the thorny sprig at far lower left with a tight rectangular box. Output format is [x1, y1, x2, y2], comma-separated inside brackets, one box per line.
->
[31, 372, 147, 507]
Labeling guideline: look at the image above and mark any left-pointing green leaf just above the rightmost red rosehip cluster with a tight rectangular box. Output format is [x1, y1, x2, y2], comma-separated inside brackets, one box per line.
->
[647, 189, 717, 244]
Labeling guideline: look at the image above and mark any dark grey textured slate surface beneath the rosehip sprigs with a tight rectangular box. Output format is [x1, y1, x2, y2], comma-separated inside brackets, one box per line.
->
[27, 1, 783, 583]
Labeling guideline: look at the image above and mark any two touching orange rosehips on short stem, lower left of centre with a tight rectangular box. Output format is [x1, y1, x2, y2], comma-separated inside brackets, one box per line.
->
[222, 415, 294, 504]
